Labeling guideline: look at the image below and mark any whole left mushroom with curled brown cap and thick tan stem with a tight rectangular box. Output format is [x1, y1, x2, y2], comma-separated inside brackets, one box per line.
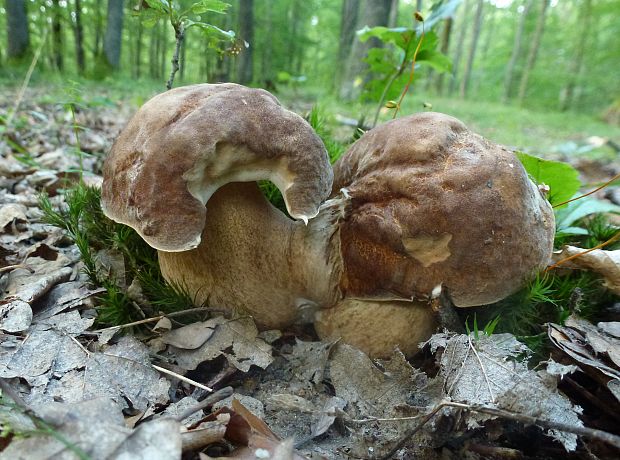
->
[102, 84, 340, 329]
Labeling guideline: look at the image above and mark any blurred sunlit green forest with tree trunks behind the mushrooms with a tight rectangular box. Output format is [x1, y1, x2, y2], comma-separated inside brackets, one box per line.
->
[0, 0, 620, 155]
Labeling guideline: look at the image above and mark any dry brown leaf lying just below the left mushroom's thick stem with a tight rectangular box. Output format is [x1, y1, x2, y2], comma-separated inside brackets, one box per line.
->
[162, 317, 273, 372]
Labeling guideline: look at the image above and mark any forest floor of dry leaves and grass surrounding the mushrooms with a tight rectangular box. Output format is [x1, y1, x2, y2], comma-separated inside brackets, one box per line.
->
[0, 85, 620, 460]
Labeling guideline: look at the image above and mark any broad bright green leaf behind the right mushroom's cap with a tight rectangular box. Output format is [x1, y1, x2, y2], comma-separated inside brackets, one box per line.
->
[515, 152, 581, 205]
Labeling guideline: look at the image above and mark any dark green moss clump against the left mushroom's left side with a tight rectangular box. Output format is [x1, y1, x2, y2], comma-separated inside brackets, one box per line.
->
[39, 183, 194, 325]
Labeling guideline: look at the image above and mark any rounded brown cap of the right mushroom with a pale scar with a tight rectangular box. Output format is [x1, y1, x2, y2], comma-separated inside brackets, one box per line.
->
[333, 112, 554, 307]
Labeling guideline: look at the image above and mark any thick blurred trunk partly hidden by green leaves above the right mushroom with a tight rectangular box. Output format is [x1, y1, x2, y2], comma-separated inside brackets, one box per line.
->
[340, 0, 392, 100]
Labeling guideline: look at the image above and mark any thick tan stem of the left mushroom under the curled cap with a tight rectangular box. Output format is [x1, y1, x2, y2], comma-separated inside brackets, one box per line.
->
[158, 182, 340, 329]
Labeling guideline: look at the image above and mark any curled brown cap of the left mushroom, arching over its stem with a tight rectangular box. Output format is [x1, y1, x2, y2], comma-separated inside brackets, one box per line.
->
[102, 83, 333, 252]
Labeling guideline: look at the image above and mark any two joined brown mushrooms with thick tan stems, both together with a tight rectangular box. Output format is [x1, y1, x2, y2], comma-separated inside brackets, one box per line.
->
[102, 84, 554, 356]
